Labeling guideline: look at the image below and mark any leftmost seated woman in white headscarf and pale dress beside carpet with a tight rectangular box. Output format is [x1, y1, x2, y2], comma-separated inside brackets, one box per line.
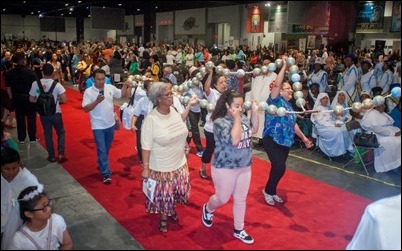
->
[311, 93, 353, 157]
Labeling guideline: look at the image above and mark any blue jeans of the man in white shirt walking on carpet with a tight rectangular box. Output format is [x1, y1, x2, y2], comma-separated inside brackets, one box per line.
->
[92, 126, 115, 177]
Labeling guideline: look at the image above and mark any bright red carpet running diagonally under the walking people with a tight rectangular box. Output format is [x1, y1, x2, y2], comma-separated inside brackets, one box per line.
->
[38, 88, 370, 249]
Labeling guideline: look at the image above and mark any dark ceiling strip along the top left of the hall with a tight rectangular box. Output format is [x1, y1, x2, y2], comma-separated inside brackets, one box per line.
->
[1, 0, 263, 17]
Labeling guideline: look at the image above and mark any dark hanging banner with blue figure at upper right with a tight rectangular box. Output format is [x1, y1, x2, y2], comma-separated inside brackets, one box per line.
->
[356, 1, 385, 33]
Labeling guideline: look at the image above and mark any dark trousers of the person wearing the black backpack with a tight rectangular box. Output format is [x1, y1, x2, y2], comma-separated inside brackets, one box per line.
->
[40, 113, 65, 158]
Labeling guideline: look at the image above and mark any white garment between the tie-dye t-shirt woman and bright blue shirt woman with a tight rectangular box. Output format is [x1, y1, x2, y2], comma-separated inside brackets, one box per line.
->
[246, 72, 277, 139]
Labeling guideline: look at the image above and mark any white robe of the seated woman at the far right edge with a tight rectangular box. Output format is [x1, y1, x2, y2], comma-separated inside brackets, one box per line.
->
[360, 109, 401, 172]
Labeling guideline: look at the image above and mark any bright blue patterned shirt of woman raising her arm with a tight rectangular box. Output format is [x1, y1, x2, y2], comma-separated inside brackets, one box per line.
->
[263, 95, 297, 147]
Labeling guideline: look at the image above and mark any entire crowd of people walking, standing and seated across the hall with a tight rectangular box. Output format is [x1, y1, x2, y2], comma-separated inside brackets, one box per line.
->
[1, 36, 401, 248]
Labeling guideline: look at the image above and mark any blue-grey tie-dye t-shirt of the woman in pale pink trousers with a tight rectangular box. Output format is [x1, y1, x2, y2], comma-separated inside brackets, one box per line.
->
[212, 115, 253, 169]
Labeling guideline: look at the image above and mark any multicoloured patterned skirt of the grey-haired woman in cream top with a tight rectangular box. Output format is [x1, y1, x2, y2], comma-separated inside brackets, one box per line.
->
[145, 163, 191, 216]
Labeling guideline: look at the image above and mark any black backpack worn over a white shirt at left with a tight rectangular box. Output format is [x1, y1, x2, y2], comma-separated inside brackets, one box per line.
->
[36, 80, 57, 116]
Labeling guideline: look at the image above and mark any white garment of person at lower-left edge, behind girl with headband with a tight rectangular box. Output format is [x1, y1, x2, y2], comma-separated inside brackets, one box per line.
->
[1, 168, 39, 250]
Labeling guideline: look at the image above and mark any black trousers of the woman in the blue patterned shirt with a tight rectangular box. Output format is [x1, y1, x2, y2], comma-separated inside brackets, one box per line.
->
[262, 136, 290, 195]
